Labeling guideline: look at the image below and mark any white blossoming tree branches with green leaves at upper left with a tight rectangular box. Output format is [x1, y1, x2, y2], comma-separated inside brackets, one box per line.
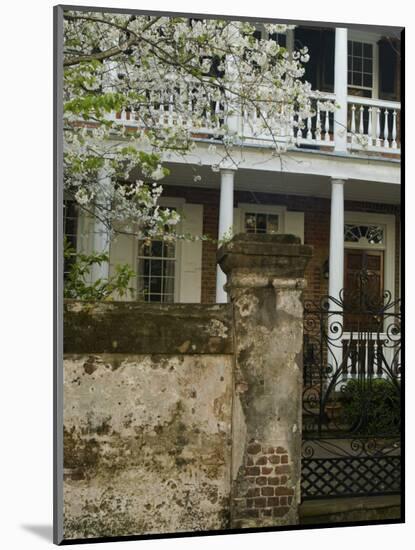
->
[64, 11, 330, 238]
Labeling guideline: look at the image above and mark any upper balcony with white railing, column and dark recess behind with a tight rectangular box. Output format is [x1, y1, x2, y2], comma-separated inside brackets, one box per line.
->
[112, 26, 401, 159]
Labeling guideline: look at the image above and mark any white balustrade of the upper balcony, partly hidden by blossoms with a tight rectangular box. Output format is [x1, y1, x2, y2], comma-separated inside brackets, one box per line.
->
[110, 89, 401, 155]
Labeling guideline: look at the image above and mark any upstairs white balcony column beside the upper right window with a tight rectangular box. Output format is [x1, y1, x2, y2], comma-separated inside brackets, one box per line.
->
[334, 28, 347, 152]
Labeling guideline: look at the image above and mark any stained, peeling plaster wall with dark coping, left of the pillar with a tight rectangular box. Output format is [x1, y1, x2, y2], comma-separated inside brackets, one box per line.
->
[64, 303, 233, 539]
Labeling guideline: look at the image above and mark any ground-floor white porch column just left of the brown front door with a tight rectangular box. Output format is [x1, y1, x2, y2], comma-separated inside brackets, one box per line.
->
[329, 179, 345, 298]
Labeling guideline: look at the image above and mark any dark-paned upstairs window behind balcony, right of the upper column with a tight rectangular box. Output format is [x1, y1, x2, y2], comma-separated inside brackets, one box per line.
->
[347, 40, 373, 97]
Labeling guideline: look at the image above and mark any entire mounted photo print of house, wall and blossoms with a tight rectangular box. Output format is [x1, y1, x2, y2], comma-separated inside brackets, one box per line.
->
[54, 6, 405, 544]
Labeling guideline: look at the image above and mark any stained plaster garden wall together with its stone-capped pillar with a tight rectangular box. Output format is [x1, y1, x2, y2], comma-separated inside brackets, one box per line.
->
[64, 235, 311, 539]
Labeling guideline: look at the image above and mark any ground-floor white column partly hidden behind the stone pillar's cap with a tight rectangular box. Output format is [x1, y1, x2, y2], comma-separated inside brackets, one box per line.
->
[216, 169, 235, 304]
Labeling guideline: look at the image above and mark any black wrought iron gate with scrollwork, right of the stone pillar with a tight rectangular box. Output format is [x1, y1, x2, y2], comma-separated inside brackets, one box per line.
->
[302, 284, 402, 500]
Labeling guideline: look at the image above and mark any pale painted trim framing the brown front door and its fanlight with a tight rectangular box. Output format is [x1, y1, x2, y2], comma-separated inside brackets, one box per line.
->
[344, 211, 396, 300]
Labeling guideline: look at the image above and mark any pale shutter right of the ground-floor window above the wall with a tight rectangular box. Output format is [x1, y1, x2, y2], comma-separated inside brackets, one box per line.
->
[180, 203, 203, 303]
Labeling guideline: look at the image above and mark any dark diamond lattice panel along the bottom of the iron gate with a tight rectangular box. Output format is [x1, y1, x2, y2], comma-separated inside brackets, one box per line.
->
[301, 456, 401, 500]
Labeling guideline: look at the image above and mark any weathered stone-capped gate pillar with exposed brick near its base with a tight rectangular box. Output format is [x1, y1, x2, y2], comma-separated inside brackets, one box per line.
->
[218, 234, 312, 528]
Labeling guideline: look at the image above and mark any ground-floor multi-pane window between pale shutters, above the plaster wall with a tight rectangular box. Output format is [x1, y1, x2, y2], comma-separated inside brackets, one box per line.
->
[137, 240, 176, 302]
